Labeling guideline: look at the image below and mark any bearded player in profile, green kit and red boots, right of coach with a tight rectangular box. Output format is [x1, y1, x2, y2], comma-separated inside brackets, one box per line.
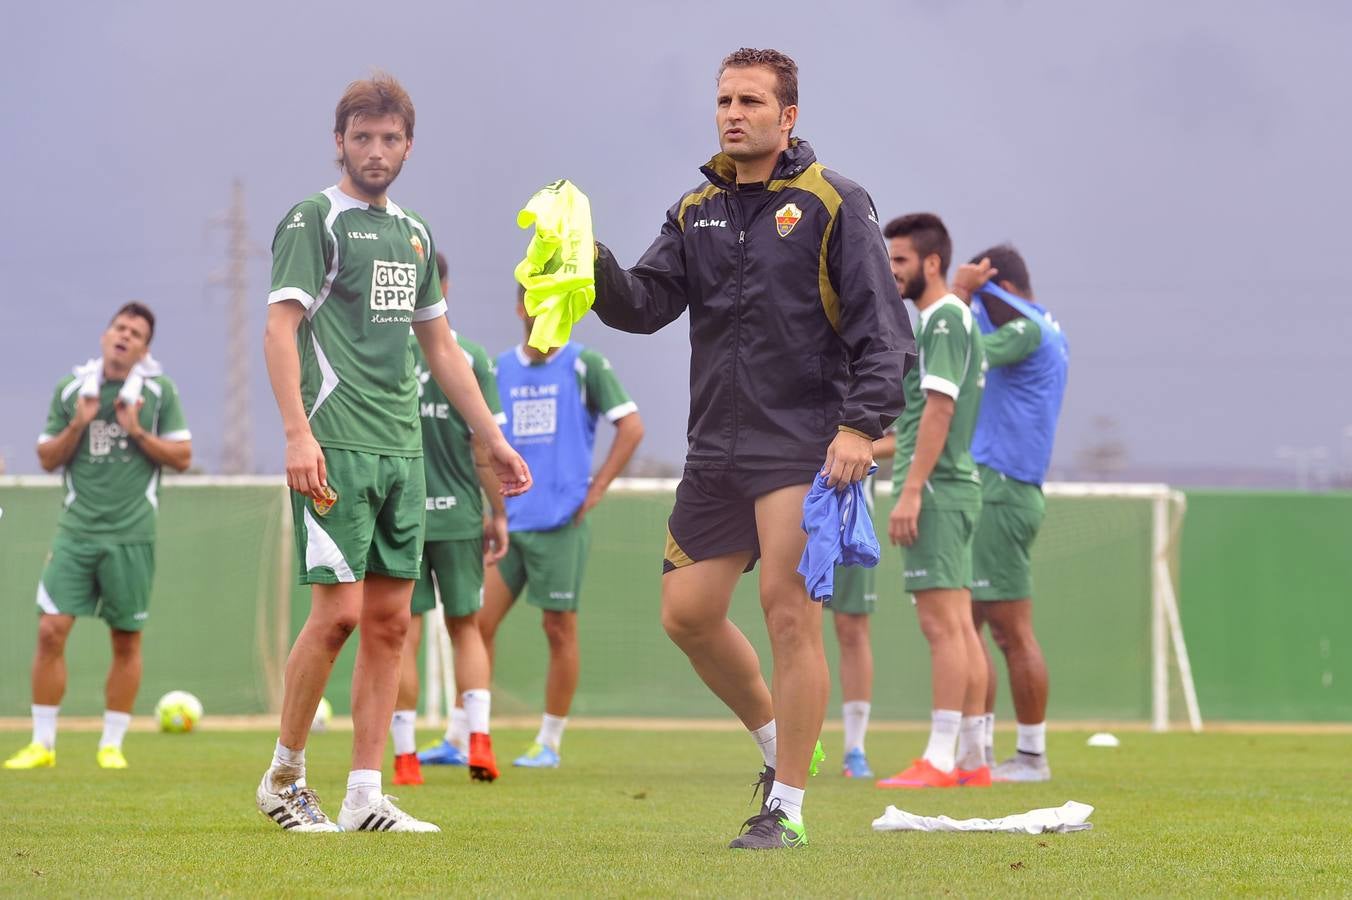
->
[877, 212, 991, 788]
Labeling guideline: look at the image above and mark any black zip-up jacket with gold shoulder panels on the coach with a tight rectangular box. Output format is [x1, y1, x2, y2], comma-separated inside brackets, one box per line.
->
[594, 139, 915, 470]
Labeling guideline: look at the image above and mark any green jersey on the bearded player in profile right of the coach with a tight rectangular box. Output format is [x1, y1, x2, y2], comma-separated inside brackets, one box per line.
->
[892, 295, 986, 511]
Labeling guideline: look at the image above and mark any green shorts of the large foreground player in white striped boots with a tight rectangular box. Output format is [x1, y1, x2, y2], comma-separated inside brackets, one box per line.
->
[291, 447, 427, 584]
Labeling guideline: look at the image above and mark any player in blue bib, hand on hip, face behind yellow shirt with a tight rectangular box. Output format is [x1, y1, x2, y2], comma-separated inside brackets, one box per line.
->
[479, 291, 644, 769]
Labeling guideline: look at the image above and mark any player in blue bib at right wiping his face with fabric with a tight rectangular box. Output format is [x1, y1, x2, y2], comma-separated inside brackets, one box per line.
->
[953, 243, 1069, 781]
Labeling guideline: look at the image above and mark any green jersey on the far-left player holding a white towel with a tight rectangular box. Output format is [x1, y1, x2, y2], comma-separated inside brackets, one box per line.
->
[38, 374, 192, 543]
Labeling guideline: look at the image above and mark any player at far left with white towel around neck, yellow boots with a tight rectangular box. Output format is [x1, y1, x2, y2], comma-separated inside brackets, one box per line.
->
[4, 303, 192, 769]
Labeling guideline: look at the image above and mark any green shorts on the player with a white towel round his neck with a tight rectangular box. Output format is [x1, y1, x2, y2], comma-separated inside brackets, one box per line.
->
[38, 532, 155, 631]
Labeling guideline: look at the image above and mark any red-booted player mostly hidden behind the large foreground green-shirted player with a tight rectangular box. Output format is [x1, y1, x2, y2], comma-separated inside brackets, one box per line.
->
[389, 253, 507, 784]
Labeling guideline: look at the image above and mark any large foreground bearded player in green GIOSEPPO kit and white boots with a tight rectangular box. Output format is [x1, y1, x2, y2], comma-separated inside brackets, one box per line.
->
[257, 74, 530, 831]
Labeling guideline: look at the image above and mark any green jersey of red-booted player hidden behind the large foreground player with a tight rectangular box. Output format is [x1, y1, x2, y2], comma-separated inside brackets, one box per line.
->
[408, 331, 507, 541]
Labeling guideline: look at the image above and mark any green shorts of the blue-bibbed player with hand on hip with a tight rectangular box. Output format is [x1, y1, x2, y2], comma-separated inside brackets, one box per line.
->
[498, 519, 591, 612]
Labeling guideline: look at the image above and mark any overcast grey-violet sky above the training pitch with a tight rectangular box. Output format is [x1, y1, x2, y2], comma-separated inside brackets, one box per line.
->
[0, 0, 1352, 473]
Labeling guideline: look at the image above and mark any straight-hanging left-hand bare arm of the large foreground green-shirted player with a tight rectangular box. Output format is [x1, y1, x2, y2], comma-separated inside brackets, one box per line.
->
[262, 300, 329, 500]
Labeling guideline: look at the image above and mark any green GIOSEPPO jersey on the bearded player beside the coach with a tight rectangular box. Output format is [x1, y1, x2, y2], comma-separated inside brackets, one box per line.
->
[268, 186, 446, 457]
